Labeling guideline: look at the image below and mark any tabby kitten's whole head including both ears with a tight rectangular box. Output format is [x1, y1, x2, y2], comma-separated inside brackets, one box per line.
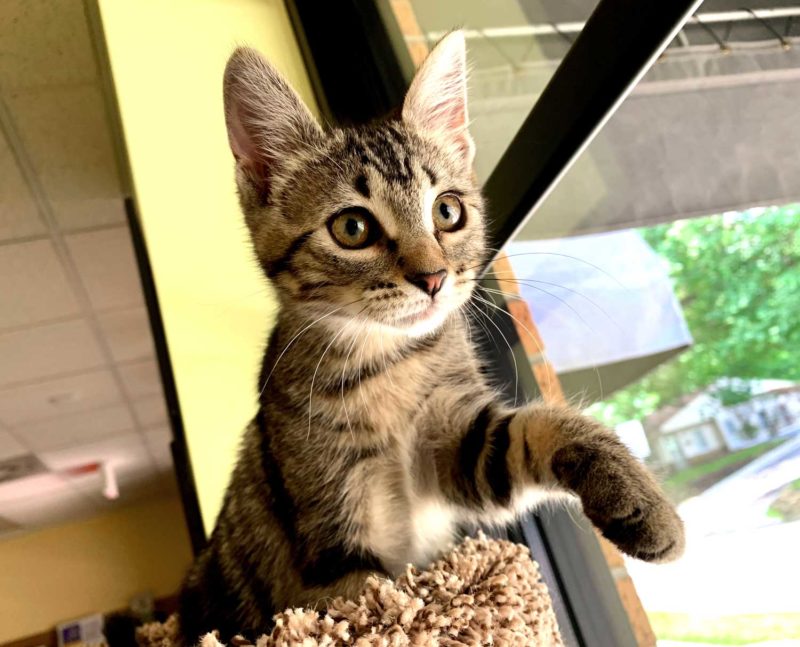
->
[226, 34, 486, 336]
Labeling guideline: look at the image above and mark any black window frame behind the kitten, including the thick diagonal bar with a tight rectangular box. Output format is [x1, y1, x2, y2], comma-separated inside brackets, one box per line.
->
[286, 0, 702, 647]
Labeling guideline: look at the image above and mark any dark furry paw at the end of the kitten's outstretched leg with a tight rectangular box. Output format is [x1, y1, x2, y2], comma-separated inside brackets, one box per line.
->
[551, 434, 685, 562]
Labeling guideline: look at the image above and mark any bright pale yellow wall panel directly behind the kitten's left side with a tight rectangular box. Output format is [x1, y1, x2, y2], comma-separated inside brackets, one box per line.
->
[99, 0, 320, 531]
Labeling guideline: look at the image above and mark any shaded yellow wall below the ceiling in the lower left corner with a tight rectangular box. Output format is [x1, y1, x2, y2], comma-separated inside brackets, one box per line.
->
[0, 497, 191, 644]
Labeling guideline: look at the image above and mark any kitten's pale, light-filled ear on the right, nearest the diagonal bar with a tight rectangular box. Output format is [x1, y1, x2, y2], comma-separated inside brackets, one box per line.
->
[403, 31, 475, 166]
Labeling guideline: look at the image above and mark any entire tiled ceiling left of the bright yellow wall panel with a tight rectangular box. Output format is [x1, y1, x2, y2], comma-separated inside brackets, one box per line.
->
[0, 0, 175, 538]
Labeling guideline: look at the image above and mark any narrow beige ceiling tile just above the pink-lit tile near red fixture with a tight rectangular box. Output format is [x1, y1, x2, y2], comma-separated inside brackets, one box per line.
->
[14, 404, 136, 452]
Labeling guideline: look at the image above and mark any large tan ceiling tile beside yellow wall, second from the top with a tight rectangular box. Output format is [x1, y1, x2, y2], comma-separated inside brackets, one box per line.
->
[7, 85, 125, 231]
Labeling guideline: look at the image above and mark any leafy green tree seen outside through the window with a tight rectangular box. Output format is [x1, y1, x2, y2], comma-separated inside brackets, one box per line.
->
[592, 204, 800, 424]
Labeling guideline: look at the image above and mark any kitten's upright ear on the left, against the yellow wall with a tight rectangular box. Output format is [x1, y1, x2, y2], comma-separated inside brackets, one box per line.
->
[223, 47, 322, 197]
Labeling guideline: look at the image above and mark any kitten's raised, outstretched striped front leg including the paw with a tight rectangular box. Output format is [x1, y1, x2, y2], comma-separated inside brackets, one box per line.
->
[436, 404, 684, 561]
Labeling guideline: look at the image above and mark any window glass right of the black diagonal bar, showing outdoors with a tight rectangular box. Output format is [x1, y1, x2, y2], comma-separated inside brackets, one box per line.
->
[495, 12, 800, 644]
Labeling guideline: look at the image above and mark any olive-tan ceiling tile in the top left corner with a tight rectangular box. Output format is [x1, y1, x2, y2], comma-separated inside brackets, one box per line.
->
[0, 0, 97, 88]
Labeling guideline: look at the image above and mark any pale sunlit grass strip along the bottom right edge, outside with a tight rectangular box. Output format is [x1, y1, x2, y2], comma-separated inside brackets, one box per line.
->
[648, 612, 800, 645]
